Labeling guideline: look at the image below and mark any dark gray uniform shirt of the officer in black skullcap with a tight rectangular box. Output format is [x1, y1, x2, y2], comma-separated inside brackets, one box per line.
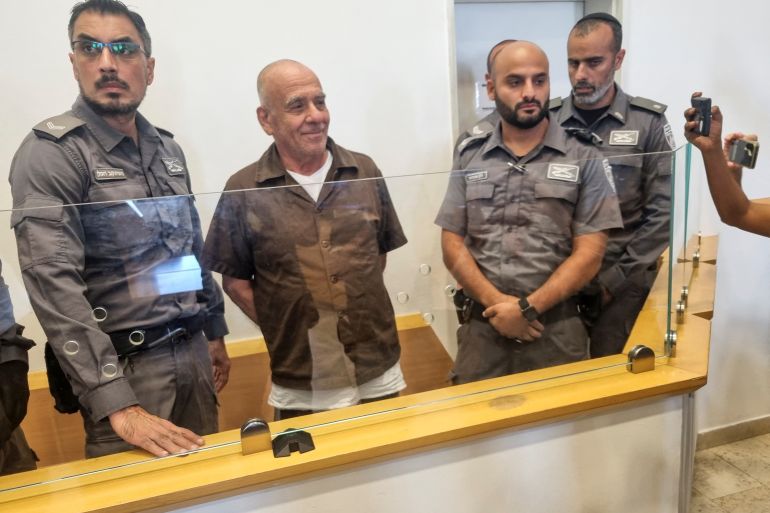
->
[551, 84, 674, 293]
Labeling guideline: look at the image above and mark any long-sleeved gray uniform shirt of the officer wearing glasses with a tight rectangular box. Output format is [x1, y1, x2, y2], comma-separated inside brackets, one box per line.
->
[9, 98, 227, 420]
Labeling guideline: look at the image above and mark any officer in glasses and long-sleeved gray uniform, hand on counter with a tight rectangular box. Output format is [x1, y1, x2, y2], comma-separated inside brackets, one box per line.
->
[10, 0, 230, 457]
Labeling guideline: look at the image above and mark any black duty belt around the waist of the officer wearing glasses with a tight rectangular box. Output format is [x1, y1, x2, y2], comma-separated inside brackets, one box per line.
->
[107, 312, 206, 357]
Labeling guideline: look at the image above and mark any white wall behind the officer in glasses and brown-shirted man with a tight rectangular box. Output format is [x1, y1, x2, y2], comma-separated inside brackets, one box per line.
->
[0, 0, 454, 368]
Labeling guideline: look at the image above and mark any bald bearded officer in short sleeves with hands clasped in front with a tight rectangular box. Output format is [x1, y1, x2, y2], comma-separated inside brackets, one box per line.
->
[436, 41, 621, 383]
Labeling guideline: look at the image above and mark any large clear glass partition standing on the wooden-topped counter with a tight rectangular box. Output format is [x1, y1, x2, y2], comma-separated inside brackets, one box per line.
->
[0, 143, 690, 500]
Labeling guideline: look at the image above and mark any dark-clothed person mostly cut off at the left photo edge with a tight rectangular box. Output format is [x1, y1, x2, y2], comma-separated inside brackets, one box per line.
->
[0, 262, 37, 475]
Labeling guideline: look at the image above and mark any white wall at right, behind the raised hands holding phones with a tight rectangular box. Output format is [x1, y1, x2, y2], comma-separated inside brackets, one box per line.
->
[623, 0, 770, 431]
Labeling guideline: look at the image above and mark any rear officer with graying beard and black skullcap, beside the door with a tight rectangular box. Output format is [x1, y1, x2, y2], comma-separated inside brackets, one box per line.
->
[550, 13, 674, 357]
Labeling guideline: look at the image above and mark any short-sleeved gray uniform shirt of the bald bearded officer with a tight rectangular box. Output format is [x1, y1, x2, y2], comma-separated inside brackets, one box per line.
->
[436, 115, 621, 297]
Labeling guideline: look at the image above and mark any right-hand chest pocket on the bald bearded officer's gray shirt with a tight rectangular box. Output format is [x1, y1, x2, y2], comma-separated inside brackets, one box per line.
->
[531, 182, 578, 236]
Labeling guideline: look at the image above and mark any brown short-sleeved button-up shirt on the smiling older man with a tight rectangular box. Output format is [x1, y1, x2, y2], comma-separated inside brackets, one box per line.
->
[203, 139, 406, 389]
